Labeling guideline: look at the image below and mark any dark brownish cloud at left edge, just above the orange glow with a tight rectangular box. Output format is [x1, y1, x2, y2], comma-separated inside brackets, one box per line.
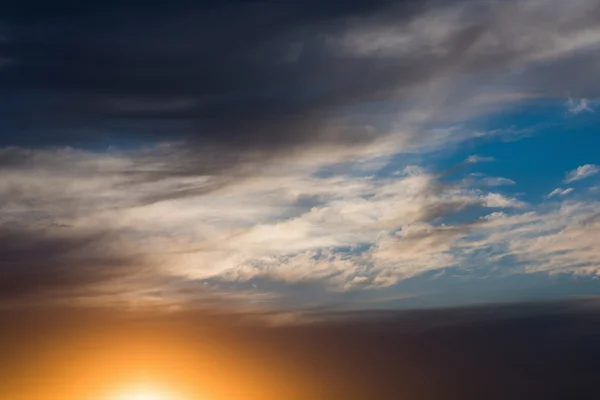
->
[0, 227, 147, 302]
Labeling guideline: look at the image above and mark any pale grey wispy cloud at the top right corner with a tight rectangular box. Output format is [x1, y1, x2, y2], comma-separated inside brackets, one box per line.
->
[335, 0, 600, 62]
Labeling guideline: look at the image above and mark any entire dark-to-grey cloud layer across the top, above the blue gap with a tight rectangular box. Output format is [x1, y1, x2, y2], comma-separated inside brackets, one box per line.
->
[0, 0, 600, 174]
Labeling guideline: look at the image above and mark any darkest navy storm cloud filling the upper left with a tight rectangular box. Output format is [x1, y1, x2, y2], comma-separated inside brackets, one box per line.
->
[0, 2, 404, 148]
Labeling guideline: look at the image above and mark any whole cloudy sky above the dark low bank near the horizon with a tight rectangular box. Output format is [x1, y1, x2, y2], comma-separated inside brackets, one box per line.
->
[0, 0, 600, 316]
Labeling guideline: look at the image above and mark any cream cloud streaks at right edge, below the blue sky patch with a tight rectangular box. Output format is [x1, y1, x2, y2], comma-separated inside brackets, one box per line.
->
[366, 202, 600, 284]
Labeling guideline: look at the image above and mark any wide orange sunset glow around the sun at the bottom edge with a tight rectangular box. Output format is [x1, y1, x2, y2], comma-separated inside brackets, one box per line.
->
[0, 314, 314, 400]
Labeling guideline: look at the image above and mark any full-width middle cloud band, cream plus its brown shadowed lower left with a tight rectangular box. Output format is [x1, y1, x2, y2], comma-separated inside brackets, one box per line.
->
[0, 144, 600, 309]
